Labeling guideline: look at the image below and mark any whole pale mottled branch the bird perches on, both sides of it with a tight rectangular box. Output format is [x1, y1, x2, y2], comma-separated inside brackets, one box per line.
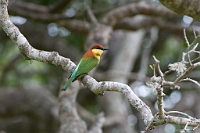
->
[0, 0, 153, 125]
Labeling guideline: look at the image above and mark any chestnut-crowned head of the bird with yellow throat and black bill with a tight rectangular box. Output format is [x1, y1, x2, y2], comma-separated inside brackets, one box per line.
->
[90, 44, 108, 60]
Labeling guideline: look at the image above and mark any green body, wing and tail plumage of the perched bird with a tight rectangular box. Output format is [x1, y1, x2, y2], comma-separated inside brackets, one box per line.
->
[62, 57, 99, 91]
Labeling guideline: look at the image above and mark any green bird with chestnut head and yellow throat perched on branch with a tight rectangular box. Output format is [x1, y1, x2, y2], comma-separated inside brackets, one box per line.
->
[61, 44, 108, 91]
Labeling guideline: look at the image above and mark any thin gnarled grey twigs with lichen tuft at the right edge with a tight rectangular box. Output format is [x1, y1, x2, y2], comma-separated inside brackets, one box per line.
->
[146, 30, 200, 131]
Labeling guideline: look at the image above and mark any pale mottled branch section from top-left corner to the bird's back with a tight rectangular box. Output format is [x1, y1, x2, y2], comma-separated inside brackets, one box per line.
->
[0, 0, 75, 70]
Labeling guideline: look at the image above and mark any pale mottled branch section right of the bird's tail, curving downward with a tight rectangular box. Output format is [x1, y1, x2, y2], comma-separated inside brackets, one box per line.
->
[82, 75, 153, 125]
